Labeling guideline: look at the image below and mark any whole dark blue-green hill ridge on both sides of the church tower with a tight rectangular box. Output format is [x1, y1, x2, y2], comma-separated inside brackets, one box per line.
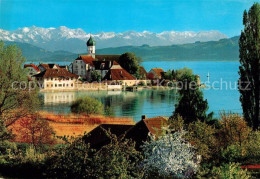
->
[6, 36, 239, 62]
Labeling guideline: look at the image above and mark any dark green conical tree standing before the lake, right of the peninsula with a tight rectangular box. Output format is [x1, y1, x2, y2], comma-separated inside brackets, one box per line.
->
[172, 73, 213, 123]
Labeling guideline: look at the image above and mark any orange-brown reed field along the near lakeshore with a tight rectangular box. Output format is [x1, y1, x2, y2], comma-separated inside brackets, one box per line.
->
[9, 112, 135, 142]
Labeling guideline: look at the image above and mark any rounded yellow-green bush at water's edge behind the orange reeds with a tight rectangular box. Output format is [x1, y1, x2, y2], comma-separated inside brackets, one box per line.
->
[71, 96, 104, 115]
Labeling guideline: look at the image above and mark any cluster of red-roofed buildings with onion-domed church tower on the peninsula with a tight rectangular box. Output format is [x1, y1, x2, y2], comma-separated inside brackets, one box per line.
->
[24, 37, 167, 90]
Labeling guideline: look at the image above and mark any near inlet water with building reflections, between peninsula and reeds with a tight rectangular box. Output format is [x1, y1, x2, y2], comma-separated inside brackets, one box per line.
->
[41, 90, 176, 121]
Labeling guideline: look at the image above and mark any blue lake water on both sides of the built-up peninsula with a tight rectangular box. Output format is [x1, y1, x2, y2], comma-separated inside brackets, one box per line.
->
[39, 61, 242, 121]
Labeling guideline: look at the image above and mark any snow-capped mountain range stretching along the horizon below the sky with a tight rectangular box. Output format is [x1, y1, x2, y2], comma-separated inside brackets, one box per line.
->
[0, 26, 228, 53]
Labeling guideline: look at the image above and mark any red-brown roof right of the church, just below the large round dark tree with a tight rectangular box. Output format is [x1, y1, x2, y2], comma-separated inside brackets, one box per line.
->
[103, 68, 135, 80]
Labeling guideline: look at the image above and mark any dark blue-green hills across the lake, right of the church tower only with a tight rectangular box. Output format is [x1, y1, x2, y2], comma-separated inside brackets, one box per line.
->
[96, 36, 239, 61]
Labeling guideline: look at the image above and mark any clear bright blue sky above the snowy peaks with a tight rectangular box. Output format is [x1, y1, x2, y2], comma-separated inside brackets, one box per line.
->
[0, 0, 257, 37]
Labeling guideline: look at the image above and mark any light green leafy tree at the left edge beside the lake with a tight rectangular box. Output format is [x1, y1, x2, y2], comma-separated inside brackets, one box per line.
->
[0, 42, 39, 126]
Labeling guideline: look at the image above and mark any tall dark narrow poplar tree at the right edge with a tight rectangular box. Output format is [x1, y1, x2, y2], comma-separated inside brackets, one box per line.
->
[239, 3, 260, 130]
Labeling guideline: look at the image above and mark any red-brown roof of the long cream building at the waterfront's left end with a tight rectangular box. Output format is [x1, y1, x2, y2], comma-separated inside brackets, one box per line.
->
[34, 68, 78, 78]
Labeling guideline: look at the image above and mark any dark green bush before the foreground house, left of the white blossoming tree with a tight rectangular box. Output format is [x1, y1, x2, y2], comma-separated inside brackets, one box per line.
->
[87, 131, 143, 178]
